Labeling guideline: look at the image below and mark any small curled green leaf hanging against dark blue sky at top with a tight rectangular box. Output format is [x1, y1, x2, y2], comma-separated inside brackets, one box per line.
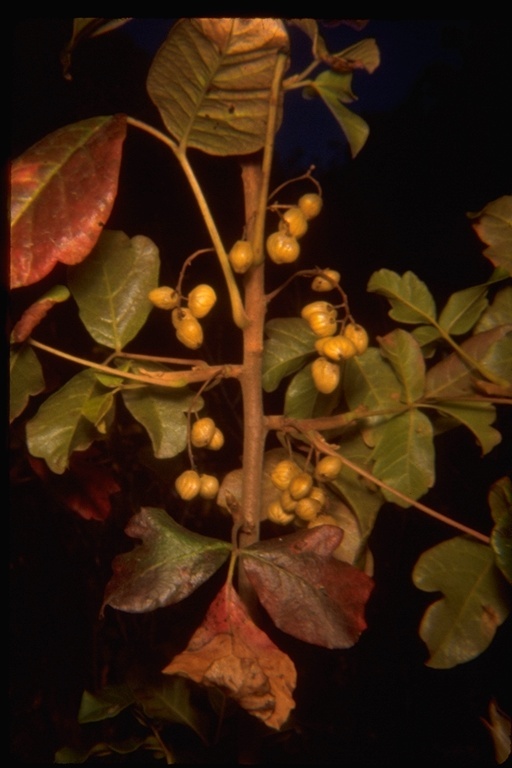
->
[310, 70, 370, 157]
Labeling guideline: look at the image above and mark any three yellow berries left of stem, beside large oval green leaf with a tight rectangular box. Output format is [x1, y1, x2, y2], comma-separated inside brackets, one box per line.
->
[148, 283, 217, 349]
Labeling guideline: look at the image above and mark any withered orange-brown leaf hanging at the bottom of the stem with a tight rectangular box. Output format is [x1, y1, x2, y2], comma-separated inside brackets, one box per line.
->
[163, 585, 297, 729]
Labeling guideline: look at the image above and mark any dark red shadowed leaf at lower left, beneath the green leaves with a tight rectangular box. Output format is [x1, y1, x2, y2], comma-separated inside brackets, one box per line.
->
[29, 454, 120, 522]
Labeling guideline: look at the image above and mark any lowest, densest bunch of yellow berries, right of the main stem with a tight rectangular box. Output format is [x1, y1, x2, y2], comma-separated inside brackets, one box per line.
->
[267, 456, 342, 525]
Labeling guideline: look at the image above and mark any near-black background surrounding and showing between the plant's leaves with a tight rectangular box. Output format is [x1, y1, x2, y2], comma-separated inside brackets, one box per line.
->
[10, 19, 512, 766]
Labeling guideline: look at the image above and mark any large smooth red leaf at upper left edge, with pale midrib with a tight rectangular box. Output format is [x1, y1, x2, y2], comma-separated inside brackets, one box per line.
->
[11, 115, 126, 288]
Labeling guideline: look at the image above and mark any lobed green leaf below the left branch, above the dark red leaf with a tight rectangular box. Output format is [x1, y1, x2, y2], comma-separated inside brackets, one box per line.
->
[27, 370, 112, 475]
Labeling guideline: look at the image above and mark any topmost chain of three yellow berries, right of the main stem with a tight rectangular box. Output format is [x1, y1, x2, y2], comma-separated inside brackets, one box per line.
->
[267, 192, 323, 264]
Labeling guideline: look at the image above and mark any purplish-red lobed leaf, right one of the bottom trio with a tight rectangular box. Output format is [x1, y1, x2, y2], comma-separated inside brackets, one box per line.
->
[242, 525, 373, 648]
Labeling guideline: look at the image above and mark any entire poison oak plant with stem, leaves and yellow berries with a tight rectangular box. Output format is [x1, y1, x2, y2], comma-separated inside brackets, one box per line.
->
[11, 19, 512, 762]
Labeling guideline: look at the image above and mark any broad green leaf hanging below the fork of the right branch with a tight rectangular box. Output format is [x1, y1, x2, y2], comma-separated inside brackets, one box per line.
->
[372, 408, 435, 507]
